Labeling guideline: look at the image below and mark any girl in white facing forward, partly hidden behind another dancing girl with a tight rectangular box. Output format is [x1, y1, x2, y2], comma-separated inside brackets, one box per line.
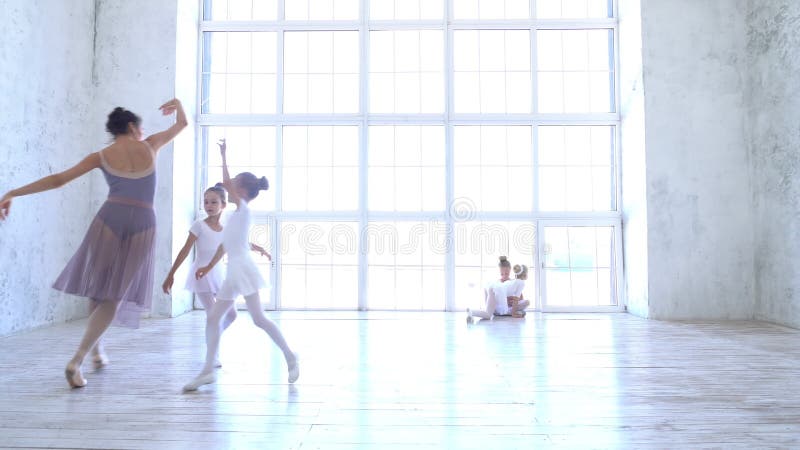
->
[161, 183, 272, 367]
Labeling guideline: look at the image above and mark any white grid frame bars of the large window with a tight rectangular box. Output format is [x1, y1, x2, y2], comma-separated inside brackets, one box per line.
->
[196, 0, 625, 311]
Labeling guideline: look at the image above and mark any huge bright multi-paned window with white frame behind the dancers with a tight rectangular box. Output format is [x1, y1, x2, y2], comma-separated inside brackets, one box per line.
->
[198, 0, 621, 310]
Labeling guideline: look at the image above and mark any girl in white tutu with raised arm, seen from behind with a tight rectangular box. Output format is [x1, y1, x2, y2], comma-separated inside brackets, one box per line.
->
[183, 140, 300, 391]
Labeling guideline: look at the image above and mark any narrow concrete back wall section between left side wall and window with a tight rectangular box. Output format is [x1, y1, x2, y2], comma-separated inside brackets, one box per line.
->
[92, 0, 191, 317]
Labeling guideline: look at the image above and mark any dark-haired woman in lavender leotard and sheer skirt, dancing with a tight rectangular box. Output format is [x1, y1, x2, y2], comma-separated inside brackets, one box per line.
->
[0, 99, 187, 387]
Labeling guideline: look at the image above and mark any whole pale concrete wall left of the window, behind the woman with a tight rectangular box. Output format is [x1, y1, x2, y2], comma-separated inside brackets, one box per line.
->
[0, 0, 199, 335]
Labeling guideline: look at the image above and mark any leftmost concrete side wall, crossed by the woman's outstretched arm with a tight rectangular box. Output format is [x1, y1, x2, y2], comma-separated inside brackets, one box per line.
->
[0, 0, 99, 335]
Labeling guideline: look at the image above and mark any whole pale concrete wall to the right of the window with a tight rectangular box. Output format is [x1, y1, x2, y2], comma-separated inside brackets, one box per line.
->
[620, 0, 800, 327]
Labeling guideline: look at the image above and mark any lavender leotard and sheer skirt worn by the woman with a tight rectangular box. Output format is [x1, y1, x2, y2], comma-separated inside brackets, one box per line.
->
[53, 149, 156, 328]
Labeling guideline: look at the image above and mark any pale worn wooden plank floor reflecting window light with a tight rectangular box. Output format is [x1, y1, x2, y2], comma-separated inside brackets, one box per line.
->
[0, 312, 800, 450]
